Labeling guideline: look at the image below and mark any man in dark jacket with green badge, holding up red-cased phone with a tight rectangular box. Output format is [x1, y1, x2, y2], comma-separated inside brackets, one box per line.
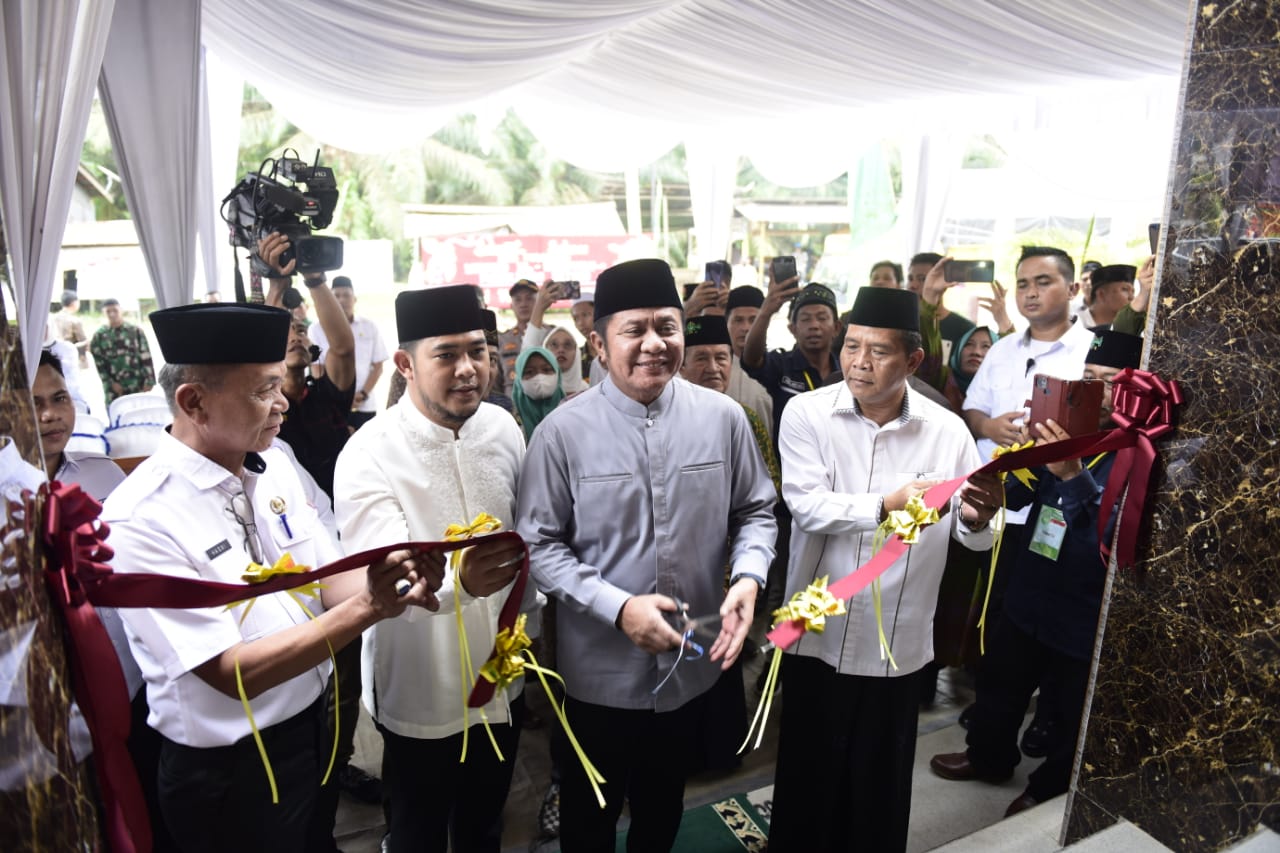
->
[929, 330, 1142, 817]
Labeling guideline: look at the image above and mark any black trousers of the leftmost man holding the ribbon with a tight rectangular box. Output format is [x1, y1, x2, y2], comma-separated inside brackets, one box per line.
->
[157, 701, 325, 853]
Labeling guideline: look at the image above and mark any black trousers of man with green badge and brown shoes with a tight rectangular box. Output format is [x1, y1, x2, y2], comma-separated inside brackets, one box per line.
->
[965, 615, 1089, 802]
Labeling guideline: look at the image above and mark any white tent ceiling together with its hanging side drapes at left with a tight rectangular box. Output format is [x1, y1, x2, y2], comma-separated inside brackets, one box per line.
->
[0, 0, 1192, 371]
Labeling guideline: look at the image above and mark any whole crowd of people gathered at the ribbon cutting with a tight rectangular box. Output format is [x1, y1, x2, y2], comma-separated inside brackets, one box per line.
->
[32, 234, 1153, 853]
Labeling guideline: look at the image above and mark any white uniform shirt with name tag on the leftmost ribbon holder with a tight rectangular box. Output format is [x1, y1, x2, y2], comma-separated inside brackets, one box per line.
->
[102, 434, 339, 747]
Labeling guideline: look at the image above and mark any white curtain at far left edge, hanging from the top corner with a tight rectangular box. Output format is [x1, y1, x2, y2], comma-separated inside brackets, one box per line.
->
[0, 0, 114, 375]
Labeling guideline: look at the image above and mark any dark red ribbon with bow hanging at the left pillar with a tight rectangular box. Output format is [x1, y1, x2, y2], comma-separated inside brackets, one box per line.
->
[41, 482, 529, 853]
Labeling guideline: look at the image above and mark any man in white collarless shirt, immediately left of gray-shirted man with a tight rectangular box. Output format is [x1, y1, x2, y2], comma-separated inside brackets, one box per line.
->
[334, 284, 538, 853]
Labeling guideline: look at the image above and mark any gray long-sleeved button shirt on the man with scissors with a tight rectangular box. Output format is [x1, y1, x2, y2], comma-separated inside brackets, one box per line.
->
[517, 378, 777, 711]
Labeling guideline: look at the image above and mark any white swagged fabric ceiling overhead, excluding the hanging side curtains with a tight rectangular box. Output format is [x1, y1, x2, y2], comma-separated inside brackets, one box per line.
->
[204, 0, 1189, 158]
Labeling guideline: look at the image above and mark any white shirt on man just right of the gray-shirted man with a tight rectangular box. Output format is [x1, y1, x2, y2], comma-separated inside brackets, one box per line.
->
[778, 383, 991, 676]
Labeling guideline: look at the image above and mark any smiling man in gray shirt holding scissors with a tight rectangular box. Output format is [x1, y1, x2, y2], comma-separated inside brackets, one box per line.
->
[517, 260, 776, 853]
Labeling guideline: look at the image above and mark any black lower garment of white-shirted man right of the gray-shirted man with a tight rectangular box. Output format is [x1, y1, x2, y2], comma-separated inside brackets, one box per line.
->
[769, 654, 920, 853]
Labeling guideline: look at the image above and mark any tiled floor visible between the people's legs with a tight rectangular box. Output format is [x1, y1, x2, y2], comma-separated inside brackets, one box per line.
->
[335, 657, 1051, 853]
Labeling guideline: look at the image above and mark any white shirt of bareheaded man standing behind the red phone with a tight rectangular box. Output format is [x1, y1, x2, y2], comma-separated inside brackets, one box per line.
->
[964, 320, 1093, 524]
